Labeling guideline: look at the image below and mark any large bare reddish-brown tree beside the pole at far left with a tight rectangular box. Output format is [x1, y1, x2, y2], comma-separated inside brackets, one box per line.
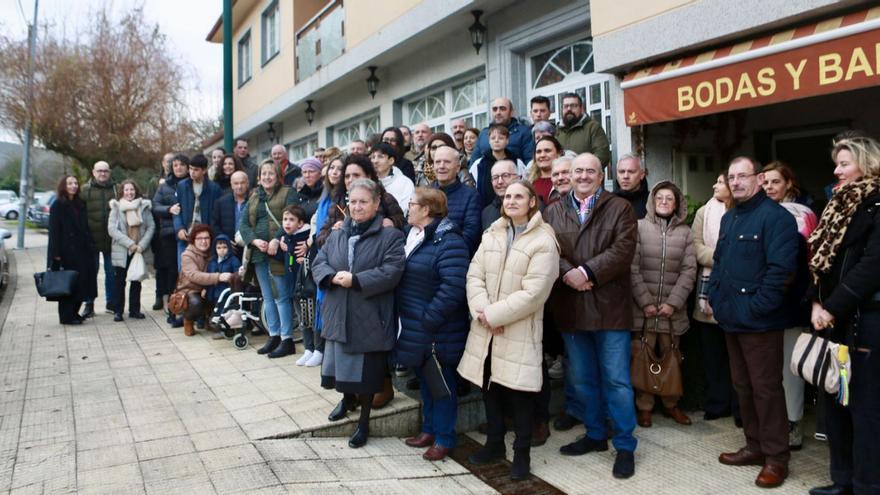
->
[0, 4, 206, 170]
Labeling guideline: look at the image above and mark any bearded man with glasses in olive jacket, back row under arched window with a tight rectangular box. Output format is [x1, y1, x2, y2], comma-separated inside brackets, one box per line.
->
[556, 93, 611, 166]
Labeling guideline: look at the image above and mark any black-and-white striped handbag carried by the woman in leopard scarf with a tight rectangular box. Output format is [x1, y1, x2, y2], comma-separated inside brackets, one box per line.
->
[789, 333, 852, 395]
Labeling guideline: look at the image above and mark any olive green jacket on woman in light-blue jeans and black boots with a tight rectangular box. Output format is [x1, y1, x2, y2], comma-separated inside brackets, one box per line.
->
[238, 186, 299, 275]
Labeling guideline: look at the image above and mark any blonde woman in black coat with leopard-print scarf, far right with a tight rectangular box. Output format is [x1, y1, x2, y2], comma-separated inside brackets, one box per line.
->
[807, 137, 880, 495]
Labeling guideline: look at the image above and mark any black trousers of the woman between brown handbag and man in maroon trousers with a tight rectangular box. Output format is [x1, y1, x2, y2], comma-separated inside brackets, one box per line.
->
[693, 320, 740, 418]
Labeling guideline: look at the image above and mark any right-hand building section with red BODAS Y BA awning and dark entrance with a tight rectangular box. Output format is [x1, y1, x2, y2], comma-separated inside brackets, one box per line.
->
[590, 0, 880, 208]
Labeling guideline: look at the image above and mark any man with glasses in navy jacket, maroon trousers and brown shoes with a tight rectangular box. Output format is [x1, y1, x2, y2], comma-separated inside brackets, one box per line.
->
[708, 157, 800, 488]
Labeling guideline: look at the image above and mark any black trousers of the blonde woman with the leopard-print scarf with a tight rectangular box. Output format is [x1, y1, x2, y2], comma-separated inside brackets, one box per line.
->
[820, 312, 880, 495]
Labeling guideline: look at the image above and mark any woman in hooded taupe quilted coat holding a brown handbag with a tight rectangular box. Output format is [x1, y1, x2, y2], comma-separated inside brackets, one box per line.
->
[631, 181, 697, 427]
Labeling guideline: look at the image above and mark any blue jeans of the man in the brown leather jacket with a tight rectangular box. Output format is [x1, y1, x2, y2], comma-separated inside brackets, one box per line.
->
[562, 330, 638, 452]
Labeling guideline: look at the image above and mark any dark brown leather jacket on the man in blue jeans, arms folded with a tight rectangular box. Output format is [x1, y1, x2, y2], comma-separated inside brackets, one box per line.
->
[544, 191, 638, 332]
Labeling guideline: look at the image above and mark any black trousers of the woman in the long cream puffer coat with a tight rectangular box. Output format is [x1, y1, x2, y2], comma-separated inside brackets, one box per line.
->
[483, 346, 537, 450]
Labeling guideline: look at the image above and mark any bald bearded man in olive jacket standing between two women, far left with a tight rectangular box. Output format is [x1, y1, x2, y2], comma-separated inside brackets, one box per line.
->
[80, 161, 116, 318]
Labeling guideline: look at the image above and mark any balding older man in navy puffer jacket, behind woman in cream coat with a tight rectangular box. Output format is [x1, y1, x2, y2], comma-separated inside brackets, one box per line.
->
[431, 146, 483, 256]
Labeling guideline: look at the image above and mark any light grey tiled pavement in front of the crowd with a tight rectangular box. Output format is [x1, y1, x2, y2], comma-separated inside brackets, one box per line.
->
[0, 231, 827, 495]
